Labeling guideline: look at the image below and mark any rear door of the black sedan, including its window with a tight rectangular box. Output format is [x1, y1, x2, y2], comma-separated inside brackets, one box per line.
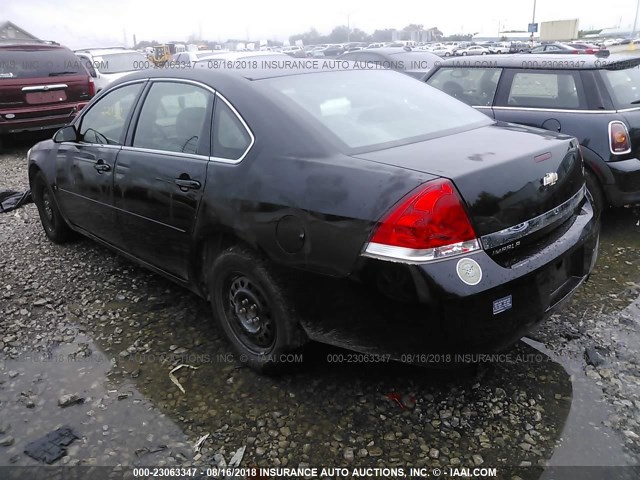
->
[114, 80, 215, 279]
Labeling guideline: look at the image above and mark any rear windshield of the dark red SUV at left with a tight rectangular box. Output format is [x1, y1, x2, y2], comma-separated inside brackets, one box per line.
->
[0, 48, 87, 80]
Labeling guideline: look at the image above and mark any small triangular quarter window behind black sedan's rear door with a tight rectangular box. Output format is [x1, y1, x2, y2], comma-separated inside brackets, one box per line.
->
[213, 98, 253, 160]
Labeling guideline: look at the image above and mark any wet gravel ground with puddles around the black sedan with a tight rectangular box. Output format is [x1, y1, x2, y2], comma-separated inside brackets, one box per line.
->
[0, 135, 640, 478]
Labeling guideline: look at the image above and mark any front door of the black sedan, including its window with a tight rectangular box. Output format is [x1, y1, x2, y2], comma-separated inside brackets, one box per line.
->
[56, 82, 143, 246]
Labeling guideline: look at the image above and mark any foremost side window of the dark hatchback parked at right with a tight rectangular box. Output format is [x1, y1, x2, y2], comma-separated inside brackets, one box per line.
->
[427, 67, 502, 107]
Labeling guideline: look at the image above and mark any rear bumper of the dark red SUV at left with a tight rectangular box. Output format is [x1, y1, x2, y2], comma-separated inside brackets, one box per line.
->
[0, 102, 87, 135]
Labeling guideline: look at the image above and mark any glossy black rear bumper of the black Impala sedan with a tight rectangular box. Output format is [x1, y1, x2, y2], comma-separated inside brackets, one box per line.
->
[296, 195, 600, 364]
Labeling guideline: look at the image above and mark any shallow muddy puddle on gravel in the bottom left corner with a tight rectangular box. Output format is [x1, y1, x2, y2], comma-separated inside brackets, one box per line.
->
[0, 335, 192, 465]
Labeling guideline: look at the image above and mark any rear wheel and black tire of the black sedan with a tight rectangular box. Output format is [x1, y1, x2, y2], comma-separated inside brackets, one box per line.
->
[207, 246, 307, 373]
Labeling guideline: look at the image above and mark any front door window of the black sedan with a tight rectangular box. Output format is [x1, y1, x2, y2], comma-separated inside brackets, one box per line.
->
[80, 83, 142, 145]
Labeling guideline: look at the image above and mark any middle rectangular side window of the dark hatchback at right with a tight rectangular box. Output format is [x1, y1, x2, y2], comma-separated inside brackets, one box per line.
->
[507, 71, 584, 109]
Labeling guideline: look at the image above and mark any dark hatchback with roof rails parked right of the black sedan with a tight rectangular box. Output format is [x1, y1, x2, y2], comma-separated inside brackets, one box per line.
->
[426, 54, 640, 208]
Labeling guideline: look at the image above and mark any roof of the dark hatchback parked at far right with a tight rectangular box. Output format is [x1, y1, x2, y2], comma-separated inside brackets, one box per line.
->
[432, 53, 640, 70]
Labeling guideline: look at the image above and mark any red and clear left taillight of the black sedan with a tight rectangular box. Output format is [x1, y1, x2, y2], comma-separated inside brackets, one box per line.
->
[364, 179, 480, 263]
